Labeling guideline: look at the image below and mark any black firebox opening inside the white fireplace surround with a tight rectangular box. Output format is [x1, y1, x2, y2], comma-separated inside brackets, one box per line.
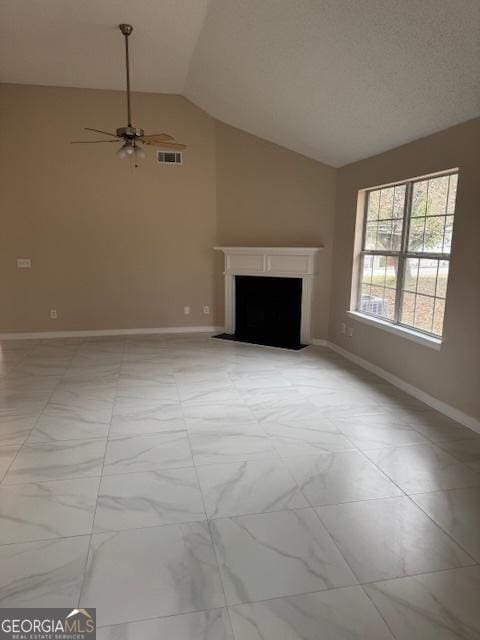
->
[218, 276, 305, 349]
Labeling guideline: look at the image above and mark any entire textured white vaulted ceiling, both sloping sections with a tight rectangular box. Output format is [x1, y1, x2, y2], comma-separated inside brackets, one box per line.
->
[0, 0, 480, 166]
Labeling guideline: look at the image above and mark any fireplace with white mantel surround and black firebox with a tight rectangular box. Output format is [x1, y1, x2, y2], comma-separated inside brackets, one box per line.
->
[215, 247, 320, 349]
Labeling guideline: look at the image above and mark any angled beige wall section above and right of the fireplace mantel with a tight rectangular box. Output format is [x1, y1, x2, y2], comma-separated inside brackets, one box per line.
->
[217, 122, 335, 338]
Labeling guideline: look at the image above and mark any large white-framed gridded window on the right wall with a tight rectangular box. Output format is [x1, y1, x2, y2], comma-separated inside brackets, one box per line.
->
[357, 171, 458, 337]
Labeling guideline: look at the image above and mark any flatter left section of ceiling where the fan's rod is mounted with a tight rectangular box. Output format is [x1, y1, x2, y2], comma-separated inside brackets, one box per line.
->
[0, 0, 208, 93]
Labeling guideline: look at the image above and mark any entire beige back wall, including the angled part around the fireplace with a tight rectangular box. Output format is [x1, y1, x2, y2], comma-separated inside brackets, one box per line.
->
[0, 85, 335, 337]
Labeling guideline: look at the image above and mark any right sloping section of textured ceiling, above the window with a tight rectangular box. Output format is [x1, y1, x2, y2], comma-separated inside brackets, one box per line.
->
[186, 0, 480, 165]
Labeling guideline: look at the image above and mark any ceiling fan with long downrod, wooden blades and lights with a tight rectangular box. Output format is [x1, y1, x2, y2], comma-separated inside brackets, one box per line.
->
[71, 24, 186, 166]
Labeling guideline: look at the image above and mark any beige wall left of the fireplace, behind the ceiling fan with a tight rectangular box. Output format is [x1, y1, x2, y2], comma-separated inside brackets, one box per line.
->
[0, 85, 216, 331]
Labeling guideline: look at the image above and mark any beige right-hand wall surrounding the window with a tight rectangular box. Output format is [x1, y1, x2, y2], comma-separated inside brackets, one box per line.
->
[330, 119, 480, 418]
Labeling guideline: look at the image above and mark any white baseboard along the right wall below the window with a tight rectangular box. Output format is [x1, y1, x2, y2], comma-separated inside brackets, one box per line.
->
[326, 340, 480, 433]
